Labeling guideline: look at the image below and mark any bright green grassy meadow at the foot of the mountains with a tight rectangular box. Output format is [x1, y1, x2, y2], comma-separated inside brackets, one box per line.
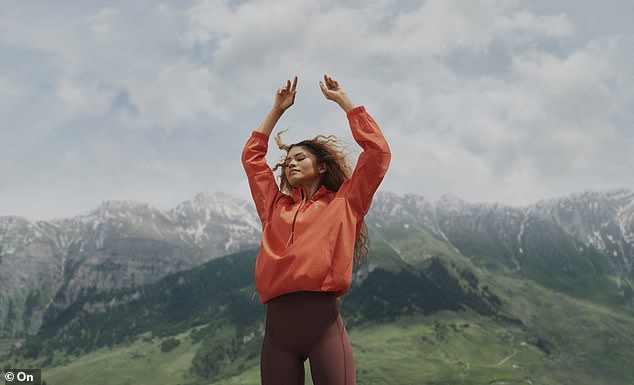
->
[32, 272, 634, 385]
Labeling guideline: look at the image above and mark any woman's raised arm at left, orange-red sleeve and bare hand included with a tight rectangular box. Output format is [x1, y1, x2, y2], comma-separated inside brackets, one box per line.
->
[242, 76, 297, 224]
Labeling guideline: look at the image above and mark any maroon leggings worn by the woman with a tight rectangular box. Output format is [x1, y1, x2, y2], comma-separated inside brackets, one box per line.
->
[260, 291, 356, 385]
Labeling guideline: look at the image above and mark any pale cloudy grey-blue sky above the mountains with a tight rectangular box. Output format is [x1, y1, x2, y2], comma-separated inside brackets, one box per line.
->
[0, 0, 634, 219]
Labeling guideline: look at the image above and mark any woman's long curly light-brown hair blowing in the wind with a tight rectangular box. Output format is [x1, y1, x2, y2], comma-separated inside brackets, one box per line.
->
[273, 129, 370, 266]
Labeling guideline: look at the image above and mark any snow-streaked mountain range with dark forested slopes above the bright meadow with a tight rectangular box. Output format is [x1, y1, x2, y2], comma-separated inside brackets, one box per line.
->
[0, 189, 634, 383]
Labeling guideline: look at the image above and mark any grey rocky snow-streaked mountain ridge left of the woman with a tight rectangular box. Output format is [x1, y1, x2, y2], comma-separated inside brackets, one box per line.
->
[0, 193, 260, 336]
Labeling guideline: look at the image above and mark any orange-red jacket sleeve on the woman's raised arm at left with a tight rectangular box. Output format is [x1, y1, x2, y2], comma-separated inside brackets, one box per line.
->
[242, 131, 282, 224]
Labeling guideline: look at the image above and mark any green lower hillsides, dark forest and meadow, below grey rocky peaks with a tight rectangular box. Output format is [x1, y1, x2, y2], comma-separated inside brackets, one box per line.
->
[6, 222, 634, 385]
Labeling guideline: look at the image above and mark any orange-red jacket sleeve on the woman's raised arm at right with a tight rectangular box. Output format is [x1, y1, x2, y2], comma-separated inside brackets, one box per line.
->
[339, 106, 391, 216]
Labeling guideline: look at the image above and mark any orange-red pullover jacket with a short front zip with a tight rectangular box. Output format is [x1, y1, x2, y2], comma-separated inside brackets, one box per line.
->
[242, 106, 391, 303]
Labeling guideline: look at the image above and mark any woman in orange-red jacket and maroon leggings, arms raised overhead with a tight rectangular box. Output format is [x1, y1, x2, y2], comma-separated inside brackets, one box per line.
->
[242, 75, 390, 385]
